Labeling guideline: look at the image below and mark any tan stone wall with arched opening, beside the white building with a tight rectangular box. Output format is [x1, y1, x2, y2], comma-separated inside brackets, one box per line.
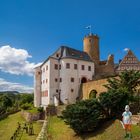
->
[82, 78, 107, 99]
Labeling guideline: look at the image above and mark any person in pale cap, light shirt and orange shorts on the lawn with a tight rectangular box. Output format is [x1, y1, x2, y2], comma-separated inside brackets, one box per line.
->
[122, 105, 132, 138]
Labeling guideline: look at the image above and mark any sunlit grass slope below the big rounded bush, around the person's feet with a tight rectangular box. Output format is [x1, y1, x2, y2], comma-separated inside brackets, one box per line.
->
[48, 116, 140, 140]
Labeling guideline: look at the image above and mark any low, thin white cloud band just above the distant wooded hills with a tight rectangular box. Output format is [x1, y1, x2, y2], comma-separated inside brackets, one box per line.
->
[0, 78, 33, 93]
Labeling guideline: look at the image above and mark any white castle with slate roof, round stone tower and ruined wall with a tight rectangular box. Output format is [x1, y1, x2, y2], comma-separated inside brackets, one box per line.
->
[34, 34, 140, 107]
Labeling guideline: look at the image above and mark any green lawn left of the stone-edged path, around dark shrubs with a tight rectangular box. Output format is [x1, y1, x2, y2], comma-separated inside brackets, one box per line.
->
[0, 112, 42, 140]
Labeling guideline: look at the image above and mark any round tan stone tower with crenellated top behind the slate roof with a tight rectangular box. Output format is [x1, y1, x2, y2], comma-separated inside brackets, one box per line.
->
[83, 34, 100, 64]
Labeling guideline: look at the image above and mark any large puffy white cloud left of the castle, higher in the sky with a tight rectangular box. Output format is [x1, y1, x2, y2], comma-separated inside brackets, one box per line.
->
[0, 45, 41, 76]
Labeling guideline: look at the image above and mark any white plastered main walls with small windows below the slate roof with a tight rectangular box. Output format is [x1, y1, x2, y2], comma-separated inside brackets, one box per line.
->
[35, 58, 94, 107]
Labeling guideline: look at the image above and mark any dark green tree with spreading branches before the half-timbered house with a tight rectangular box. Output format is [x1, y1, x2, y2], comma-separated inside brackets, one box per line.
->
[99, 71, 140, 117]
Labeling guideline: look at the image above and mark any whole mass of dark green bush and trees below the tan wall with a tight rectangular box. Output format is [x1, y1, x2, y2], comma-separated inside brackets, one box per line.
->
[62, 71, 140, 133]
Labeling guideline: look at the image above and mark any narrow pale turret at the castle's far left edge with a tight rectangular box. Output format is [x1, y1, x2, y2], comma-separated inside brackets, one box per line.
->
[34, 67, 41, 107]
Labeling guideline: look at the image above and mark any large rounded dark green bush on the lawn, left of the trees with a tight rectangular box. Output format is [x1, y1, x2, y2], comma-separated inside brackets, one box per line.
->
[62, 99, 102, 134]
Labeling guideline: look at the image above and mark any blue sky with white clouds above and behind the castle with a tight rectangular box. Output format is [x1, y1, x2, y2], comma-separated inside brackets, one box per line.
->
[0, 0, 140, 91]
